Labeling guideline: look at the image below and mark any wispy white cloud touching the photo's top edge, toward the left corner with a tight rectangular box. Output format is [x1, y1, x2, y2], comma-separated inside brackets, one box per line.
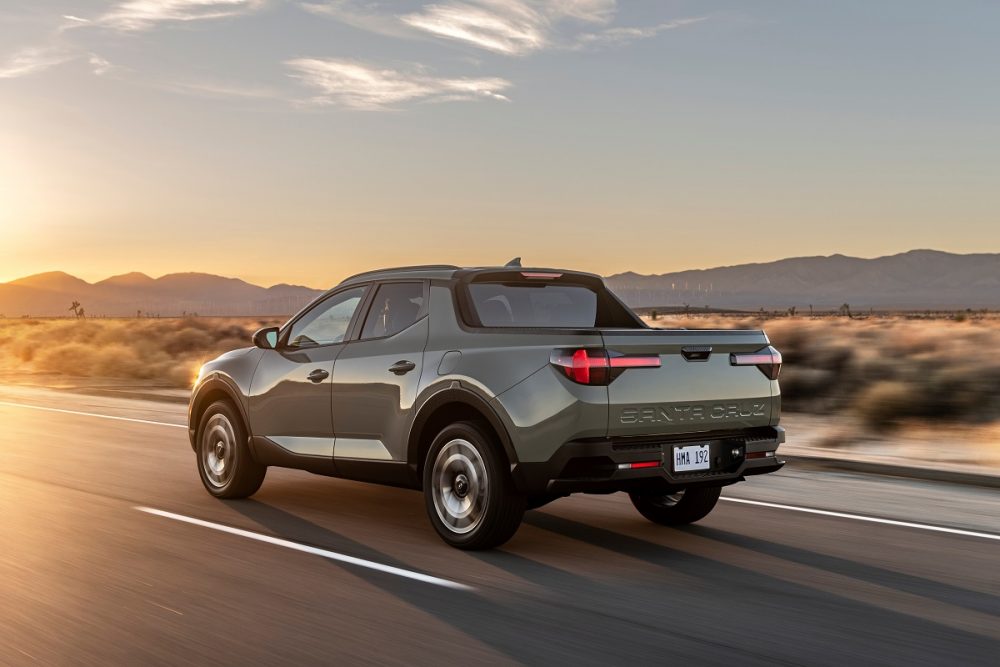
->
[97, 0, 265, 31]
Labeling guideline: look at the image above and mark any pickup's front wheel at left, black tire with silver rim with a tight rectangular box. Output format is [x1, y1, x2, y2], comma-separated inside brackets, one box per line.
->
[195, 401, 267, 498]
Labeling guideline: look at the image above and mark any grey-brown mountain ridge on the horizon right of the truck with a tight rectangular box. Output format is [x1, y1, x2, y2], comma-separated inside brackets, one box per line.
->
[607, 250, 1000, 310]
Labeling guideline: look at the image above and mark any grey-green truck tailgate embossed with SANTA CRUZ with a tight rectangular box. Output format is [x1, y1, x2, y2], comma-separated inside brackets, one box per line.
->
[601, 329, 781, 437]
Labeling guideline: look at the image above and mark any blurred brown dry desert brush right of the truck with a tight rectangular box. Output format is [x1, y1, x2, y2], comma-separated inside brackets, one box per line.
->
[651, 315, 1000, 430]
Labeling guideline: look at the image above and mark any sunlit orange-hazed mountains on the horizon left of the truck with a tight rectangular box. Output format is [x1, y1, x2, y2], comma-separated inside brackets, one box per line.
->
[0, 271, 322, 317]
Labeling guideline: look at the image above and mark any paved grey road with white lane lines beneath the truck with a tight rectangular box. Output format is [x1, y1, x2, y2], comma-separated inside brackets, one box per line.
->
[0, 388, 1000, 665]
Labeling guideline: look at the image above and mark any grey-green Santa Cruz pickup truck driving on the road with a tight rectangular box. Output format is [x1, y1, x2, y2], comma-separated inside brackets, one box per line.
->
[188, 265, 784, 549]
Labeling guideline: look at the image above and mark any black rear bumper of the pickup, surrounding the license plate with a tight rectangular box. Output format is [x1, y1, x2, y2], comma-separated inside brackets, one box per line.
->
[512, 426, 785, 496]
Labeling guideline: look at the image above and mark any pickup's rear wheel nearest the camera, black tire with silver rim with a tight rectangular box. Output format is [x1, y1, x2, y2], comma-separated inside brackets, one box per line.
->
[423, 422, 526, 550]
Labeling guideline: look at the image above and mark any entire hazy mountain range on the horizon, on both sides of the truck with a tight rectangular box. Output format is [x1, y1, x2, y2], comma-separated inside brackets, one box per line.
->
[0, 250, 1000, 317]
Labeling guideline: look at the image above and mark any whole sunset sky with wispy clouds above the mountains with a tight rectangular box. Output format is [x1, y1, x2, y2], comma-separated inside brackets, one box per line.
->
[0, 0, 1000, 287]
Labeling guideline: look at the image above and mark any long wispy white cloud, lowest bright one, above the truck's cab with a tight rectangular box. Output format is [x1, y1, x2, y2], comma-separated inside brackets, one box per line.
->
[285, 58, 511, 110]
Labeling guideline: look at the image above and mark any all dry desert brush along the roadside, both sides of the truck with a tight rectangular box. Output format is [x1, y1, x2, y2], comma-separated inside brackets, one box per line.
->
[0, 315, 1000, 430]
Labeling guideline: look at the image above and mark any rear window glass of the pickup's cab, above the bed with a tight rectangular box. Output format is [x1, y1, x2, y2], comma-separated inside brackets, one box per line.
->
[469, 283, 597, 329]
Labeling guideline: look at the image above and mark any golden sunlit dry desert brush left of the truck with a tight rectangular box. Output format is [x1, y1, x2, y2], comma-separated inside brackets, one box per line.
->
[0, 317, 276, 387]
